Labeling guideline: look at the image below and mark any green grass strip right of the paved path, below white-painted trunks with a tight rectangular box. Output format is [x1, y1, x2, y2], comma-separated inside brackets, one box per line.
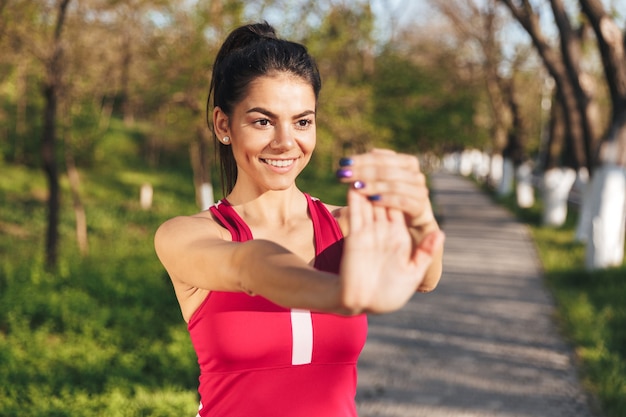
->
[498, 189, 626, 417]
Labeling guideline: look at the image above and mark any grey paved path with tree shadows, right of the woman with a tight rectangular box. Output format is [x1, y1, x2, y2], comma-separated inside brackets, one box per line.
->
[357, 173, 594, 417]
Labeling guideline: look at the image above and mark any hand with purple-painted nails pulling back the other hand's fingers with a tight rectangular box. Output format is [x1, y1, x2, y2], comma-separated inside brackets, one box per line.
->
[337, 149, 438, 231]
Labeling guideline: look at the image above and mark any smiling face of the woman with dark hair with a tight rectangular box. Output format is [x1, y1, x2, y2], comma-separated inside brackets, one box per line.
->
[222, 73, 316, 192]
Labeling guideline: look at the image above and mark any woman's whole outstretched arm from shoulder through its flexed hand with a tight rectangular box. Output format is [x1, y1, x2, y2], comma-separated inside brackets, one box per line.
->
[155, 190, 442, 317]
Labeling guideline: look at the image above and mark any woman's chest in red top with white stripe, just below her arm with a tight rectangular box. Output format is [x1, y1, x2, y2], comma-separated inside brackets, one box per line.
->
[192, 292, 367, 372]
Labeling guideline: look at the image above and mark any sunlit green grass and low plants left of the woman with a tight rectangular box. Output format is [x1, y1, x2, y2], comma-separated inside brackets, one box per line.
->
[0, 166, 197, 417]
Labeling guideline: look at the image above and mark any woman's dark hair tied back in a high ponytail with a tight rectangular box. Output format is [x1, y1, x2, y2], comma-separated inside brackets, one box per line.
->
[207, 22, 322, 195]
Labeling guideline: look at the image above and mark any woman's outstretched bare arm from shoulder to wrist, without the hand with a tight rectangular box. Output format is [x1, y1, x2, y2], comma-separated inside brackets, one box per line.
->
[155, 216, 346, 314]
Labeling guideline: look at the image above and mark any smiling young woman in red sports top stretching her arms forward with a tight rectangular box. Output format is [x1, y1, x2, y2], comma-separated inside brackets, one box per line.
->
[155, 23, 443, 417]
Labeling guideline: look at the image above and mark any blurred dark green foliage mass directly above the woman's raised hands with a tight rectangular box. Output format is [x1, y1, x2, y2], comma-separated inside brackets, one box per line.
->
[373, 47, 488, 153]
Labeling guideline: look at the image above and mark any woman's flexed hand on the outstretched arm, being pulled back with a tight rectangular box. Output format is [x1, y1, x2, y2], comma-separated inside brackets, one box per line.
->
[339, 189, 443, 313]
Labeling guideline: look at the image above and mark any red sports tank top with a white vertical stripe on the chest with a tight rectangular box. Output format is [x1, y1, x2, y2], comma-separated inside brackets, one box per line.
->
[188, 195, 367, 417]
